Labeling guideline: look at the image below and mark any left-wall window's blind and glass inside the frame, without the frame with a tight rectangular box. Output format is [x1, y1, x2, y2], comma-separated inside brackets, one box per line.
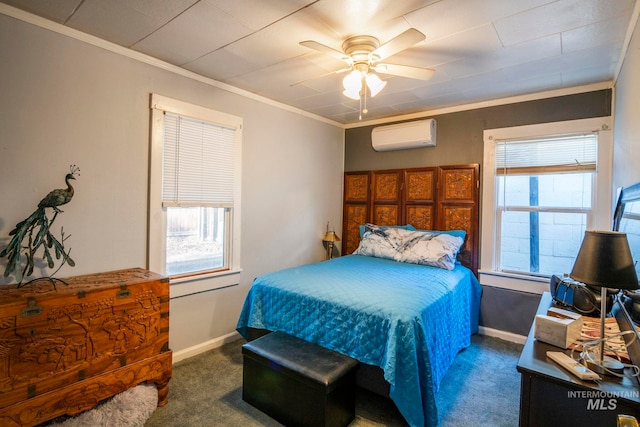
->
[162, 112, 235, 276]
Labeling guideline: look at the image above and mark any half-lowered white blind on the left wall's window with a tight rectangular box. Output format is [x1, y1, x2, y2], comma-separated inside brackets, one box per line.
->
[162, 112, 235, 207]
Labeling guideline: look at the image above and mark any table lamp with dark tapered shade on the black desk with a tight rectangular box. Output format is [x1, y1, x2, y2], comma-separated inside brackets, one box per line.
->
[570, 230, 638, 374]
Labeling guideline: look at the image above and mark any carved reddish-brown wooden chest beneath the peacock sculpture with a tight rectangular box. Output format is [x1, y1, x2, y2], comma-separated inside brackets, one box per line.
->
[0, 269, 171, 426]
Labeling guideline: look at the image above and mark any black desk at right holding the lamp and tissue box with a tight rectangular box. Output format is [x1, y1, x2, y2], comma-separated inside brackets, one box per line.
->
[517, 292, 640, 427]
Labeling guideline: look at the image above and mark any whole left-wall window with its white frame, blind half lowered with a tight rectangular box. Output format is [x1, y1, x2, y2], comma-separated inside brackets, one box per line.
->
[149, 95, 242, 294]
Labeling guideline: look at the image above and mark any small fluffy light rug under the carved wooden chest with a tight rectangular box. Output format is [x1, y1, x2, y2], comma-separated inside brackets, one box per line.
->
[44, 384, 158, 427]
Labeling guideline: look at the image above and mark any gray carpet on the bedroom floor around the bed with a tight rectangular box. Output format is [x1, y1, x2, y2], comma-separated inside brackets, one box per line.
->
[145, 335, 522, 427]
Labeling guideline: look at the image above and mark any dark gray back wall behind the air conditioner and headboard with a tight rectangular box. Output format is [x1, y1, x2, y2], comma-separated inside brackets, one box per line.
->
[345, 90, 612, 335]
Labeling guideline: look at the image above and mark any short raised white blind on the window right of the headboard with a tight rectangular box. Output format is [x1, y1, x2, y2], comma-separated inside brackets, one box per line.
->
[495, 133, 598, 175]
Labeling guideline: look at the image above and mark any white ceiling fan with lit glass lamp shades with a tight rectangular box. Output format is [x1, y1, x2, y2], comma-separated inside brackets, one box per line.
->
[298, 28, 435, 113]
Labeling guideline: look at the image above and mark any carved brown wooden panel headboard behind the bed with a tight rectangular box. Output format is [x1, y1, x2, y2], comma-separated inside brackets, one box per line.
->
[342, 164, 480, 276]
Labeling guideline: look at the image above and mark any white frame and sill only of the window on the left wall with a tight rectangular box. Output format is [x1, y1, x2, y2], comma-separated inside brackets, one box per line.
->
[147, 94, 243, 298]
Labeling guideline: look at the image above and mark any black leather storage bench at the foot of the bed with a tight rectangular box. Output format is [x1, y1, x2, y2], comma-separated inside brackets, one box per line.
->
[242, 332, 358, 427]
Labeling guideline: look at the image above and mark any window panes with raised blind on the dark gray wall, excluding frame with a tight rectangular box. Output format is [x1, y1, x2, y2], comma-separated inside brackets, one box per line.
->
[495, 133, 598, 276]
